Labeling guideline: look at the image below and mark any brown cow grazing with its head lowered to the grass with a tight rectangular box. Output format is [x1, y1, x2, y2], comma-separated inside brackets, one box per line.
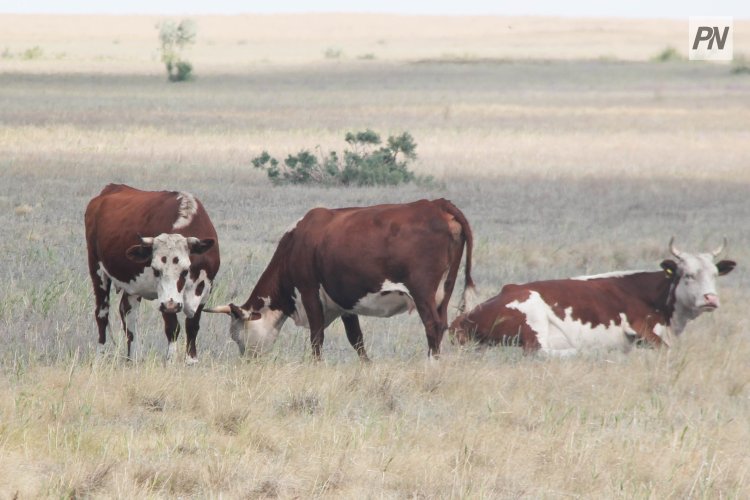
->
[206, 199, 474, 361]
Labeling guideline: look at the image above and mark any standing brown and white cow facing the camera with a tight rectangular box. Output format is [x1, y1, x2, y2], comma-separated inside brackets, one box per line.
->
[85, 184, 220, 364]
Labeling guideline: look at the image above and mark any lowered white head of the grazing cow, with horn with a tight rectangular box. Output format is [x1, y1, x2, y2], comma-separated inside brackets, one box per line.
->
[204, 299, 286, 356]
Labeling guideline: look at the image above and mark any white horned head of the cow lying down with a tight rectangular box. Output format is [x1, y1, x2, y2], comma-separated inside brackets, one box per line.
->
[661, 237, 736, 319]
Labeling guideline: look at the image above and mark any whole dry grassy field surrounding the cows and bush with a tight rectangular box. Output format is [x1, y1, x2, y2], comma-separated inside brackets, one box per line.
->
[0, 16, 750, 498]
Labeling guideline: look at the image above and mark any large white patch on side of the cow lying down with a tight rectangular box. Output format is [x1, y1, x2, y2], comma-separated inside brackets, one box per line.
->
[507, 291, 635, 356]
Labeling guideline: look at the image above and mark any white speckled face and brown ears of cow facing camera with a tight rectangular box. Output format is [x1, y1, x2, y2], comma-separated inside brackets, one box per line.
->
[126, 233, 214, 316]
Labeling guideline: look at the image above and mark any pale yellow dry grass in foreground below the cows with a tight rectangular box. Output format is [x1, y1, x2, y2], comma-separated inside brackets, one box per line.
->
[0, 323, 750, 498]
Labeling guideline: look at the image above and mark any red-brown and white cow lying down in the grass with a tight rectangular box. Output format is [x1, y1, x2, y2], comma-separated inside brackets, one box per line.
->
[449, 237, 736, 356]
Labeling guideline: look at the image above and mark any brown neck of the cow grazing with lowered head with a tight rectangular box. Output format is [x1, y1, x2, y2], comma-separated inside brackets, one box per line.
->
[242, 232, 294, 316]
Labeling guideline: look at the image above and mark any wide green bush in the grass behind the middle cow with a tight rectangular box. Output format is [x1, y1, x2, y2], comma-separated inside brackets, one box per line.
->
[251, 130, 431, 186]
